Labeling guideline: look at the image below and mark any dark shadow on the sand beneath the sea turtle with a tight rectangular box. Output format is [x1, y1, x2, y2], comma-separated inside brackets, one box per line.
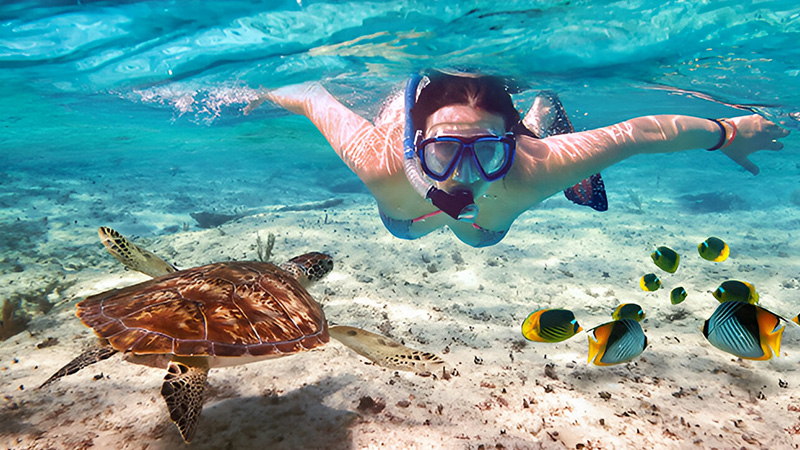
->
[155, 375, 359, 450]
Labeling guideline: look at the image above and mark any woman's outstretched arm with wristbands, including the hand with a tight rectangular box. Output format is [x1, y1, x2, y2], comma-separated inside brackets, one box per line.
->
[509, 115, 789, 203]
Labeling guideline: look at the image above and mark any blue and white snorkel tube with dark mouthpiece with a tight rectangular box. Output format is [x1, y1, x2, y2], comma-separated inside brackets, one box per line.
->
[403, 74, 478, 223]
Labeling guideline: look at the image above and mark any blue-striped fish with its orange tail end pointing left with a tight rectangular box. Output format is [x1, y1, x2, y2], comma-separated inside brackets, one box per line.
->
[588, 319, 647, 366]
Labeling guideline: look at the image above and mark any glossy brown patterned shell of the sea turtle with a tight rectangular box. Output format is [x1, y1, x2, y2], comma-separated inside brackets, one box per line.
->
[77, 262, 329, 357]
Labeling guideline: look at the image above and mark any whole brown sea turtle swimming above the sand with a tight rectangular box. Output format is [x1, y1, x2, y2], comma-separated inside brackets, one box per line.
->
[40, 227, 444, 443]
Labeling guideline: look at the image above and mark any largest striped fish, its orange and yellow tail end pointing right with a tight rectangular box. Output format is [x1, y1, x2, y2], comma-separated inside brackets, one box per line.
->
[702, 301, 785, 361]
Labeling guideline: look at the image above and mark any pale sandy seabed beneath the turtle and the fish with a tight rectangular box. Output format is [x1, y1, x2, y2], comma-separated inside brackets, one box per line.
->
[0, 160, 800, 449]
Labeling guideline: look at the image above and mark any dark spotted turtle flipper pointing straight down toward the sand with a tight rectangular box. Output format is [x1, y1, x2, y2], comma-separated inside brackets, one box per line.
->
[161, 361, 208, 444]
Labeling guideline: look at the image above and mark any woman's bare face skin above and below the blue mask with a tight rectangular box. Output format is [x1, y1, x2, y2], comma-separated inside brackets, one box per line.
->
[424, 105, 505, 197]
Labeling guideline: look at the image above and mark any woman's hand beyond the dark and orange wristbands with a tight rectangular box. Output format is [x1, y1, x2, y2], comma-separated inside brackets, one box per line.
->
[721, 114, 789, 175]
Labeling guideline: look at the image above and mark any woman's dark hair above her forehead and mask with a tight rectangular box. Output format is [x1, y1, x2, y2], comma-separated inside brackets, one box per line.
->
[411, 72, 521, 131]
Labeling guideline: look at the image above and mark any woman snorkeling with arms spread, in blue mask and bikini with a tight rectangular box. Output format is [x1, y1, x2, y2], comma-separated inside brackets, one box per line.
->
[245, 72, 788, 247]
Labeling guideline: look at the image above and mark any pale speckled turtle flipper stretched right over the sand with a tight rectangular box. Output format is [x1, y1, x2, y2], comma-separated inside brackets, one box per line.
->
[328, 325, 444, 373]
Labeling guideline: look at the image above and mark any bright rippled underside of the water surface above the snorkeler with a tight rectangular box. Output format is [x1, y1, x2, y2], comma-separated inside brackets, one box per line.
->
[0, 0, 800, 128]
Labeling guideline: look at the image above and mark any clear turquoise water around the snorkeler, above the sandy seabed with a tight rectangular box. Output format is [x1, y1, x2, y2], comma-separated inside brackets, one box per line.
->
[0, 0, 800, 253]
